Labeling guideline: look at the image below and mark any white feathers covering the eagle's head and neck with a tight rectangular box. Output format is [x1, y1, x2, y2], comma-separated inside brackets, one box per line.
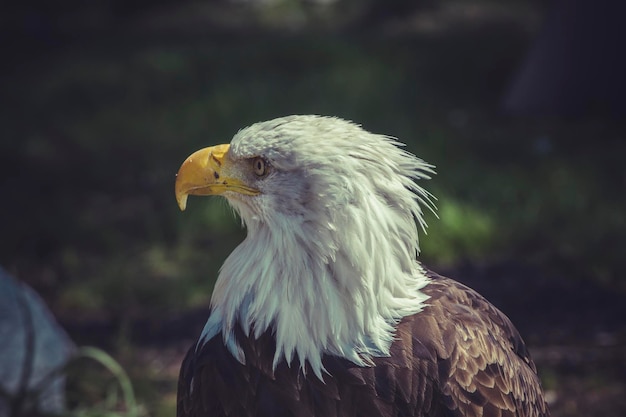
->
[200, 116, 433, 379]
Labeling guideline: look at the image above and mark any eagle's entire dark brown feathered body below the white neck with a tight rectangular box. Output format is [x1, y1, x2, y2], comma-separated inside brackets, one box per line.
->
[177, 273, 549, 417]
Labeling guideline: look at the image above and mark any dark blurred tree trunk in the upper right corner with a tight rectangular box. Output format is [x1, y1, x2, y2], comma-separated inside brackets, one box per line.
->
[503, 0, 626, 117]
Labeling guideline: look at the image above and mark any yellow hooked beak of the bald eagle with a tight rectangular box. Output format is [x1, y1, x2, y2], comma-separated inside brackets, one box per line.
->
[175, 145, 260, 210]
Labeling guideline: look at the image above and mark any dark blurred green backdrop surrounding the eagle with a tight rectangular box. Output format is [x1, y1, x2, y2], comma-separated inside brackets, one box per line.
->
[0, 0, 626, 417]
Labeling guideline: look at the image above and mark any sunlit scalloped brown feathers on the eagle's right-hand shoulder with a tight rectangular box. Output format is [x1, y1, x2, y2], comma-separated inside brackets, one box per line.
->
[420, 273, 549, 417]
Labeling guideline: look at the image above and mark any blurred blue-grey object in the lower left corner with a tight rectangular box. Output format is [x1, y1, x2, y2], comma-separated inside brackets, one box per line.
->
[0, 268, 76, 417]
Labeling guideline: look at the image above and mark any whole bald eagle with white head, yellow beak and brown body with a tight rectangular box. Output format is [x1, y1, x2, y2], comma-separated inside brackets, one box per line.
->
[176, 115, 549, 417]
